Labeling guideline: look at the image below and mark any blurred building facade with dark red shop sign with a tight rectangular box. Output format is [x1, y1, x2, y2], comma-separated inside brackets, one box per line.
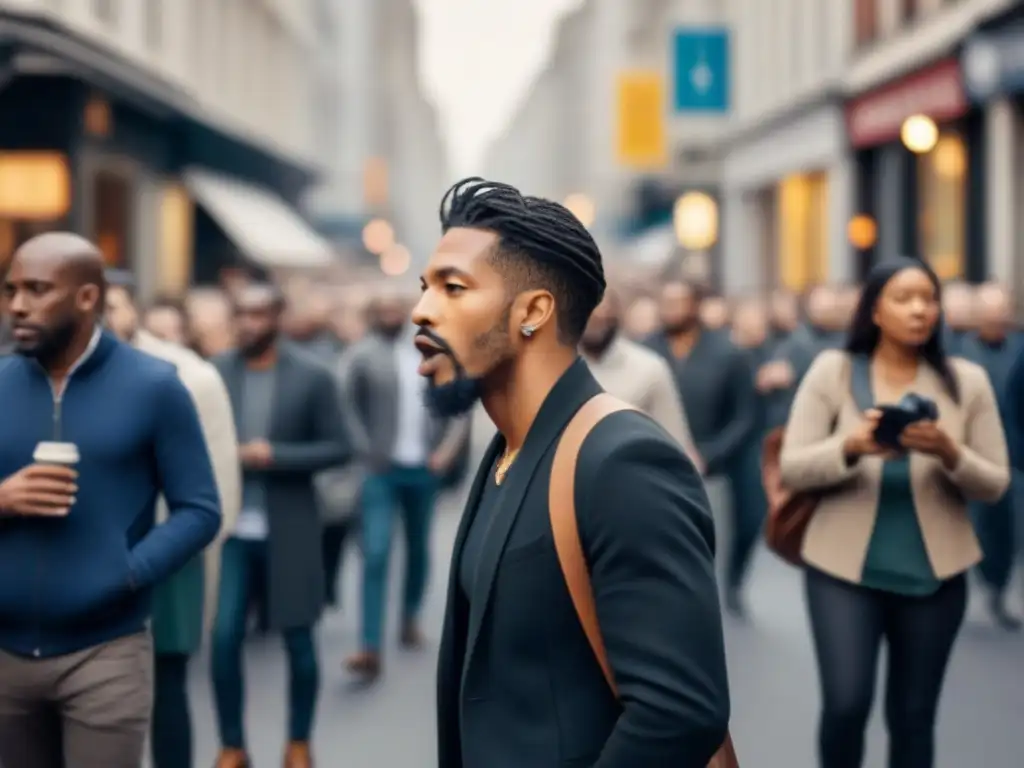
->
[844, 0, 1014, 281]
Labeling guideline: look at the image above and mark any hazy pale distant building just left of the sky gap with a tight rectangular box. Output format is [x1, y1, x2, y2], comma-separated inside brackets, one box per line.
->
[309, 0, 451, 272]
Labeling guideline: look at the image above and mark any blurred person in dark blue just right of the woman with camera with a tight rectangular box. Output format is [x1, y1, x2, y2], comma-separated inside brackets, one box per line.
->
[959, 283, 1022, 632]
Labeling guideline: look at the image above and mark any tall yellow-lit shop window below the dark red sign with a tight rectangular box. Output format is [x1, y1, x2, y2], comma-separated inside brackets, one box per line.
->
[918, 133, 968, 280]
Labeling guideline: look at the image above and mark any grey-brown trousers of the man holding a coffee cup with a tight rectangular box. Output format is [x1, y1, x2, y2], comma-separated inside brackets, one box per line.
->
[0, 632, 153, 768]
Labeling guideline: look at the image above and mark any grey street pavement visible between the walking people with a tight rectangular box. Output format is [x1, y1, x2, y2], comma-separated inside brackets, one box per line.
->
[184, 415, 1024, 768]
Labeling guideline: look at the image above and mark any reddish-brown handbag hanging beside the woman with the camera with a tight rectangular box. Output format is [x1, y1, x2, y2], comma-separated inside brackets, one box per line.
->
[761, 427, 820, 565]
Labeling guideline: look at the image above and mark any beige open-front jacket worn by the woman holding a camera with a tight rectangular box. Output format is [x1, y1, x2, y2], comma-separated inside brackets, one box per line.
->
[780, 351, 1010, 583]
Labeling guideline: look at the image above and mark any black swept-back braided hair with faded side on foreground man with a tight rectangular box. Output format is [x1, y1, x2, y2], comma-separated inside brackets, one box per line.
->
[440, 176, 605, 346]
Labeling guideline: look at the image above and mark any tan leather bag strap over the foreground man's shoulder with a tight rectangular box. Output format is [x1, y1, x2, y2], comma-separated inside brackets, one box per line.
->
[548, 393, 739, 768]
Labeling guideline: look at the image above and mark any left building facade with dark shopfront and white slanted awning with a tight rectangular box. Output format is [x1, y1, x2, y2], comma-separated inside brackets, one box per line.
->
[0, 0, 331, 293]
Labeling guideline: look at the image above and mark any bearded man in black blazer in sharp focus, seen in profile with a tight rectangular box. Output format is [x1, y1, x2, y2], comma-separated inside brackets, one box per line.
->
[413, 179, 729, 768]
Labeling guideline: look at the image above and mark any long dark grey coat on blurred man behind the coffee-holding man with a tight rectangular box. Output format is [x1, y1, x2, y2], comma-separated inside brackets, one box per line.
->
[214, 343, 350, 630]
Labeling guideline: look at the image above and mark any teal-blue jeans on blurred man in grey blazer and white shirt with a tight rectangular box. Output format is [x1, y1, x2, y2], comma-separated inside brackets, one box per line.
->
[362, 467, 437, 651]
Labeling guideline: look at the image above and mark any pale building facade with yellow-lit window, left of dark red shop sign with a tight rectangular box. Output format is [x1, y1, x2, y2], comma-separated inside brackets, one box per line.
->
[721, 0, 853, 293]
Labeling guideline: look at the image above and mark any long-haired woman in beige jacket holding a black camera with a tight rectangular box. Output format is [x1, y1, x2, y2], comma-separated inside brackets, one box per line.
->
[780, 259, 1010, 768]
